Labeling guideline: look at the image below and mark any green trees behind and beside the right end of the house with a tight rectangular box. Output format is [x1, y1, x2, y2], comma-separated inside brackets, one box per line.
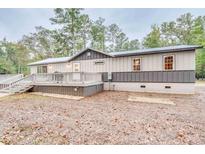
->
[143, 13, 205, 77]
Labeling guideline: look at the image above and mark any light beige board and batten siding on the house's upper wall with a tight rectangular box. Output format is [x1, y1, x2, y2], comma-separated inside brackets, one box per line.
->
[30, 51, 195, 74]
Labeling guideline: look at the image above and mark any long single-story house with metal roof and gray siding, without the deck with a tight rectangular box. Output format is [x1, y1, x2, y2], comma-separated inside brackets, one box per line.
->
[28, 45, 202, 94]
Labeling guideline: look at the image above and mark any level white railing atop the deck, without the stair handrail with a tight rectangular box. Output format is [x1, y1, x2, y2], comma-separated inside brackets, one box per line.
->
[33, 72, 102, 84]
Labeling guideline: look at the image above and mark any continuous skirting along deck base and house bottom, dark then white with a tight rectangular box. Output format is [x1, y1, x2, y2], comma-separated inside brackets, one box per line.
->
[31, 82, 195, 96]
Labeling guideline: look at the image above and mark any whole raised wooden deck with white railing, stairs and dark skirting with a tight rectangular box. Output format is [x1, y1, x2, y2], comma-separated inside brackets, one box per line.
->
[1, 72, 103, 96]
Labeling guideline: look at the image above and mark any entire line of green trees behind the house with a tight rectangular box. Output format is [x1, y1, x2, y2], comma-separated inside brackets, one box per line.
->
[0, 8, 205, 78]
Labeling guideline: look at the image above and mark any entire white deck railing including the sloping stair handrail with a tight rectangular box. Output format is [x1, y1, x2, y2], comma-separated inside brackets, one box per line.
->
[0, 72, 102, 91]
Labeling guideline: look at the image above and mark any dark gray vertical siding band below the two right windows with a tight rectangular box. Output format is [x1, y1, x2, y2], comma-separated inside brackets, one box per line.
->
[108, 70, 195, 83]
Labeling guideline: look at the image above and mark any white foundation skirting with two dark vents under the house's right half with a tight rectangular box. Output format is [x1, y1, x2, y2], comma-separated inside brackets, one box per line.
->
[104, 82, 195, 94]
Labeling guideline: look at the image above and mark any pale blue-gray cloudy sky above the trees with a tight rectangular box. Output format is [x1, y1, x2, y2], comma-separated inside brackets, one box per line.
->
[0, 9, 205, 41]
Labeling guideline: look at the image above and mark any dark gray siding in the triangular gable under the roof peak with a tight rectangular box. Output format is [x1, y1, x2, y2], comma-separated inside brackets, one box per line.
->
[72, 50, 109, 61]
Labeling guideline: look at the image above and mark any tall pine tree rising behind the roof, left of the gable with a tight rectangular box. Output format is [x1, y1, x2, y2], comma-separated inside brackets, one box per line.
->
[50, 8, 84, 55]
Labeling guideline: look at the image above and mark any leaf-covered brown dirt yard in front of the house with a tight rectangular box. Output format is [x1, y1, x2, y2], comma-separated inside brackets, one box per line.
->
[0, 86, 205, 144]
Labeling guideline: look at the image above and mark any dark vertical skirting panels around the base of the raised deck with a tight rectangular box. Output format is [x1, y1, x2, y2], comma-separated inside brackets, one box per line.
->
[32, 84, 103, 96]
